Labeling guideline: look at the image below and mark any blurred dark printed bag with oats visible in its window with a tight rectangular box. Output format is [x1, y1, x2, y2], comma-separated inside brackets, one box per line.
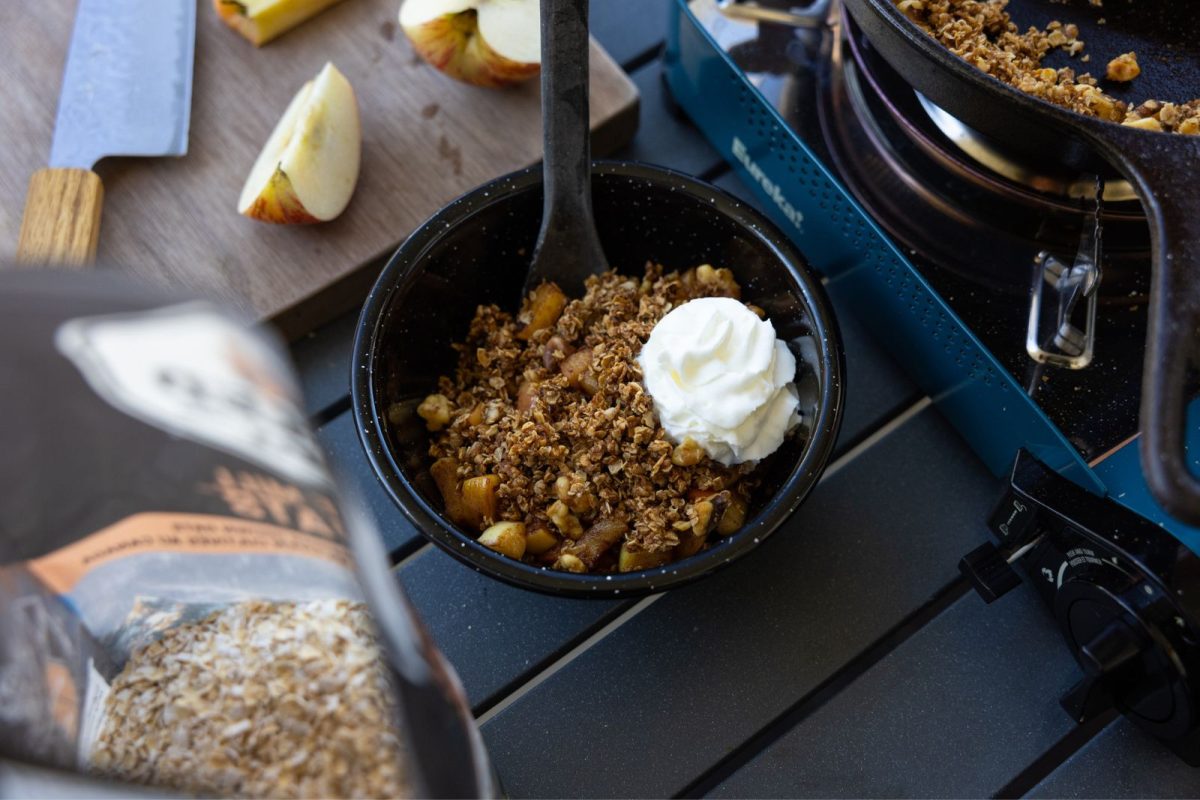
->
[0, 272, 494, 798]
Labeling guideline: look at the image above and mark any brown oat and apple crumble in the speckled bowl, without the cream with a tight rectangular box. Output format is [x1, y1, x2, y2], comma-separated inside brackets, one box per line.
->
[418, 264, 763, 572]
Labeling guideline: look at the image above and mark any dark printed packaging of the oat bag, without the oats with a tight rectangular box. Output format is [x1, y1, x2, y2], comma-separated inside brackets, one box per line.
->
[0, 273, 494, 796]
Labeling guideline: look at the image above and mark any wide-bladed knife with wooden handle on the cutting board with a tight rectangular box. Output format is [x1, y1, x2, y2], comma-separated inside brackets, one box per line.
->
[17, 0, 196, 266]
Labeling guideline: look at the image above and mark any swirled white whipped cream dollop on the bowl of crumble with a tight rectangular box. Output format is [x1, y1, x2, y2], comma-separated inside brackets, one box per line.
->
[637, 297, 800, 467]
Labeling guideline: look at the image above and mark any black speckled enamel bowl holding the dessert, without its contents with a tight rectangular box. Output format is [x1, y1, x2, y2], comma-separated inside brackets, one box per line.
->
[350, 162, 845, 596]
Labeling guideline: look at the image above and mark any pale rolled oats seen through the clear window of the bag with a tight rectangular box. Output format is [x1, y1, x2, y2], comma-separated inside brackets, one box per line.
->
[91, 600, 410, 798]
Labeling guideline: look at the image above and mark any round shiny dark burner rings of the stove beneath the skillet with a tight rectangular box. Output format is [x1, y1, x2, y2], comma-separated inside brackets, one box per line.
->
[818, 10, 1150, 293]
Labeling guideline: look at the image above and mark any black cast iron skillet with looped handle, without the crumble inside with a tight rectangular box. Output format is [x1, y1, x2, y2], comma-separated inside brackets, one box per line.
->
[845, 0, 1200, 525]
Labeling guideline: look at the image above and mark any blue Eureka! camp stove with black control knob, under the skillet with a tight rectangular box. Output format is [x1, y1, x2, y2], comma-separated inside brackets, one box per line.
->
[664, 0, 1200, 763]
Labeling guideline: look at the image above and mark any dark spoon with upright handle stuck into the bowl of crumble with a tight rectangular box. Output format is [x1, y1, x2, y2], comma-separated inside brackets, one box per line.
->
[524, 0, 608, 296]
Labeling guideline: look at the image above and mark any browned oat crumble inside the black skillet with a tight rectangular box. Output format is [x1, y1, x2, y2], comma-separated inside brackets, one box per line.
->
[893, 0, 1200, 134]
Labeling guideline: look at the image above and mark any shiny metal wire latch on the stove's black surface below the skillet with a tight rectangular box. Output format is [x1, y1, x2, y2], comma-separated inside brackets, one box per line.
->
[1025, 179, 1103, 369]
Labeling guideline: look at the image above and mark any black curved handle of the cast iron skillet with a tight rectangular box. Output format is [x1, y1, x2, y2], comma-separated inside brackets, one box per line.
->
[1120, 131, 1200, 525]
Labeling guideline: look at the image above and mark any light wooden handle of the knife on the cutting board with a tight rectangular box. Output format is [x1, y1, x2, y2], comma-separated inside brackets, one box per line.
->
[17, 168, 104, 267]
